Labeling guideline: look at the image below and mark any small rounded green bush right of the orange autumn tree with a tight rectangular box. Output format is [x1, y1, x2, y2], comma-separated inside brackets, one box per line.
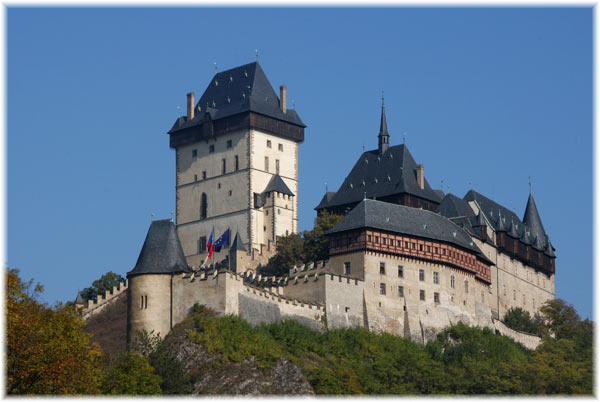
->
[102, 353, 161, 395]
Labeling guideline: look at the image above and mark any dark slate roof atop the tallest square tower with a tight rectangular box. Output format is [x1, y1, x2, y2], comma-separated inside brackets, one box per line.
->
[169, 62, 306, 133]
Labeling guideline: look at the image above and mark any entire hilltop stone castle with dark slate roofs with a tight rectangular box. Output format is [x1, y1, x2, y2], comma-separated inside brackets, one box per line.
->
[77, 62, 556, 347]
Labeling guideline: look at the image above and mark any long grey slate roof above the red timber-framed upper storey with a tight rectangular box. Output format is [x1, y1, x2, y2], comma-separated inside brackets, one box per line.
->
[328, 199, 491, 263]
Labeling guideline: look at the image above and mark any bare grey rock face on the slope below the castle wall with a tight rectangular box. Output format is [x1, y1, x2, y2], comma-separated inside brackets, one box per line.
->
[165, 319, 315, 396]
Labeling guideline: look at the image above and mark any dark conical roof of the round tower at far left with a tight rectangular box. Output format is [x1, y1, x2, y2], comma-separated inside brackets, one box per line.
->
[127, 219, 192, 276]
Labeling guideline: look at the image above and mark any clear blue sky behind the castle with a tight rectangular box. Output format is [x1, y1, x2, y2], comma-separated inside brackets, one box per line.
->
[7, 7, 593, 317]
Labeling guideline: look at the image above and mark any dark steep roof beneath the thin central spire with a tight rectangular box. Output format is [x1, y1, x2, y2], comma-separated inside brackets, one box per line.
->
[328, 144, 441, 206]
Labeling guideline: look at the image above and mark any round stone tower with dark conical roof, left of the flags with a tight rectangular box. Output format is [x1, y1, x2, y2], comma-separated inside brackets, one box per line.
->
[127, 219, 192, 347]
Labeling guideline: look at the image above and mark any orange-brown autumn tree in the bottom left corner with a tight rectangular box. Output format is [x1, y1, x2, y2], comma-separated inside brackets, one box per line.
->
[5, 269, 103, 395]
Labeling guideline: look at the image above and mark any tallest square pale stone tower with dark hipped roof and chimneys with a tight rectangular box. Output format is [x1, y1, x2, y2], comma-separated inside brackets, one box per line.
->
[169, 62, 305, 266]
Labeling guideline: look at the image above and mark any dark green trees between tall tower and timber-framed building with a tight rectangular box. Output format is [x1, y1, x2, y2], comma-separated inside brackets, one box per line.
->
[266, 211, 342, 276]
